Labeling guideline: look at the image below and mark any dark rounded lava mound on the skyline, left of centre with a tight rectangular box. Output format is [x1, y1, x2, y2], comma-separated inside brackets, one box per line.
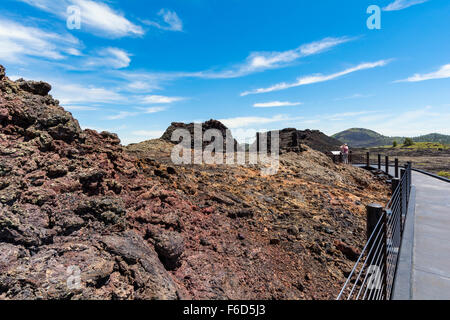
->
[161, 119, 238, 152]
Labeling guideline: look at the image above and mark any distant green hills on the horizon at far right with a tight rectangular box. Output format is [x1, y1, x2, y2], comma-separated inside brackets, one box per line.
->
[332, 128, 450, 148]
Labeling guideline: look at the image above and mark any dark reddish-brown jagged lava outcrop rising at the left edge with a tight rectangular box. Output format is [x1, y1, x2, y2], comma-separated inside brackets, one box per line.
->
[0, 66, 195, 299]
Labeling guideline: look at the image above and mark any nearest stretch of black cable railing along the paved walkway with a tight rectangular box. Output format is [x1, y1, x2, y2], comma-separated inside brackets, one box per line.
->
[337, 163, 411, 300]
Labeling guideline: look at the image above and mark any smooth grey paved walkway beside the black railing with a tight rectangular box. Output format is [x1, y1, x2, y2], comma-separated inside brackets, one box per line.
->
[411, 171, 450, 300]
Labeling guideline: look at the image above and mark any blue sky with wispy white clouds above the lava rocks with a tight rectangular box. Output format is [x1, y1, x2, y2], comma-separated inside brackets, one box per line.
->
[0, 0, 450, 144]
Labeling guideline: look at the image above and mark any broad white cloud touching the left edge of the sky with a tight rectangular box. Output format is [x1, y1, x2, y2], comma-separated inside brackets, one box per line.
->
[0, 18, 79, 62]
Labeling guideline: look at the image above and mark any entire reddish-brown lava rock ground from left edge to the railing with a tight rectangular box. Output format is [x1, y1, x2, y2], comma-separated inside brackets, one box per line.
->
[0, 67, 388, 299]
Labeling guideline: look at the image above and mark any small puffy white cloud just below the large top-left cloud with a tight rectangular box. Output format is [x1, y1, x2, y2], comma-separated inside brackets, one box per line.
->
[84, 47, 131, 69]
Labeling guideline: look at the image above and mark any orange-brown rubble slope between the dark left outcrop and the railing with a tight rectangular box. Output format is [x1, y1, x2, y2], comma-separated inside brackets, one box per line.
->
[127, 139, 389, 299]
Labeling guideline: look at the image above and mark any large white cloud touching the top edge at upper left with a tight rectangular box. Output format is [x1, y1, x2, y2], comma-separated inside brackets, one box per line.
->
[18, 0, 144, 37]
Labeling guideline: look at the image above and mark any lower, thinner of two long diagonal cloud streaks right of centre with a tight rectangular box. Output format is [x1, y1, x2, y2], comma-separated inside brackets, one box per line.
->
[241, 60, 389, 96]
